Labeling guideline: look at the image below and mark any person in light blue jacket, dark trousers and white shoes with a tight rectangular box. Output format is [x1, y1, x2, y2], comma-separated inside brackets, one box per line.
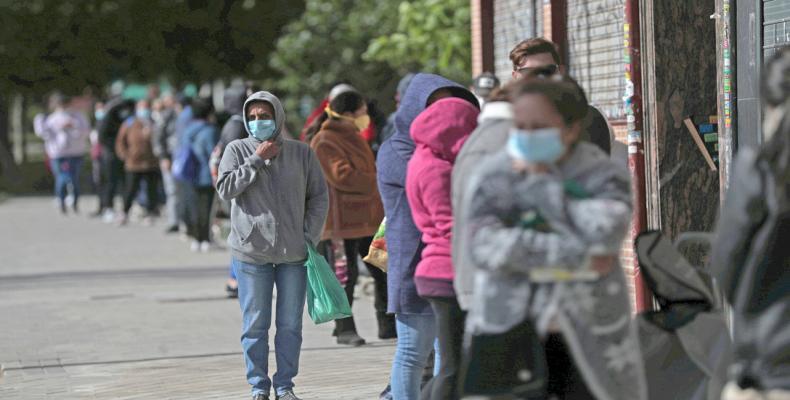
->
[179, 99, 219, 253]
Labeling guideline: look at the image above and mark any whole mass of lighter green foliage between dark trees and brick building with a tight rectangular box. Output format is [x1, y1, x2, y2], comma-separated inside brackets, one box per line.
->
[270, 0, 471, 128]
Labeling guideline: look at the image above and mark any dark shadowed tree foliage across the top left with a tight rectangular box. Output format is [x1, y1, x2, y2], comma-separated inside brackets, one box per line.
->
[0, 0, 303, 94]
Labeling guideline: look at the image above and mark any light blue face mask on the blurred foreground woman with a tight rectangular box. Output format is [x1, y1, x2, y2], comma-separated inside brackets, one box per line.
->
[507, 128, 565, 164]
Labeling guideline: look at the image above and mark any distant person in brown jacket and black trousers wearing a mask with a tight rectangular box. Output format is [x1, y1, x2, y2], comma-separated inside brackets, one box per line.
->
[115, 100, 159, 226]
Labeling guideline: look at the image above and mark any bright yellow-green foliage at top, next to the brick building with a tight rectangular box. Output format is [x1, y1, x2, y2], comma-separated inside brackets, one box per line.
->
[364, 0, 472, 82]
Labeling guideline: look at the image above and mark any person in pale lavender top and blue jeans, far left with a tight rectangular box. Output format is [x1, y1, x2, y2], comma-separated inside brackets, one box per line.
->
[36, 93, 90, 215]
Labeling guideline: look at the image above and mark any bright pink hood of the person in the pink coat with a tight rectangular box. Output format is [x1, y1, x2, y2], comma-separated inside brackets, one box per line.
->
[410, 97, 480, 163]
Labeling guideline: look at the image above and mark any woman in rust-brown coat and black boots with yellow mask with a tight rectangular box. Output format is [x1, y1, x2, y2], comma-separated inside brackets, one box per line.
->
[310, 91, 396, 346]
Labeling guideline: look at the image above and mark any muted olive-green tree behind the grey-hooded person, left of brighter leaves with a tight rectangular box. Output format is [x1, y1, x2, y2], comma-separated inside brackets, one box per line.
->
[267, 0, 400, 128]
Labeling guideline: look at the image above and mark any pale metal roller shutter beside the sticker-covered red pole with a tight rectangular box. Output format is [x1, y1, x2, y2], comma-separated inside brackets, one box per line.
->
[567, 0, 625, 120]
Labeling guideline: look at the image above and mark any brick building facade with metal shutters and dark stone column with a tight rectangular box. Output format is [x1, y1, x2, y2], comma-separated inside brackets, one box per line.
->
[471, 0, 790, 310]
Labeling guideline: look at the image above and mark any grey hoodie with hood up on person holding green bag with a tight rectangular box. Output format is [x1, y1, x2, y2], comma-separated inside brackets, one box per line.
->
[217, 92, 329, 264]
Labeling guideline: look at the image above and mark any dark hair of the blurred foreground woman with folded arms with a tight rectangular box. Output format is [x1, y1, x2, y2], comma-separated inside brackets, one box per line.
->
[505, 76, 590, 125]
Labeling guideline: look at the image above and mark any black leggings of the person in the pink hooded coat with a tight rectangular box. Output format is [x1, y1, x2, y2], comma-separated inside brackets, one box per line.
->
[420, 297, 466, 400]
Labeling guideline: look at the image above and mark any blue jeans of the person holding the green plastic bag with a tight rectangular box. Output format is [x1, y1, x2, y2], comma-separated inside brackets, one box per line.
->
[232, 259, 307, 396]
